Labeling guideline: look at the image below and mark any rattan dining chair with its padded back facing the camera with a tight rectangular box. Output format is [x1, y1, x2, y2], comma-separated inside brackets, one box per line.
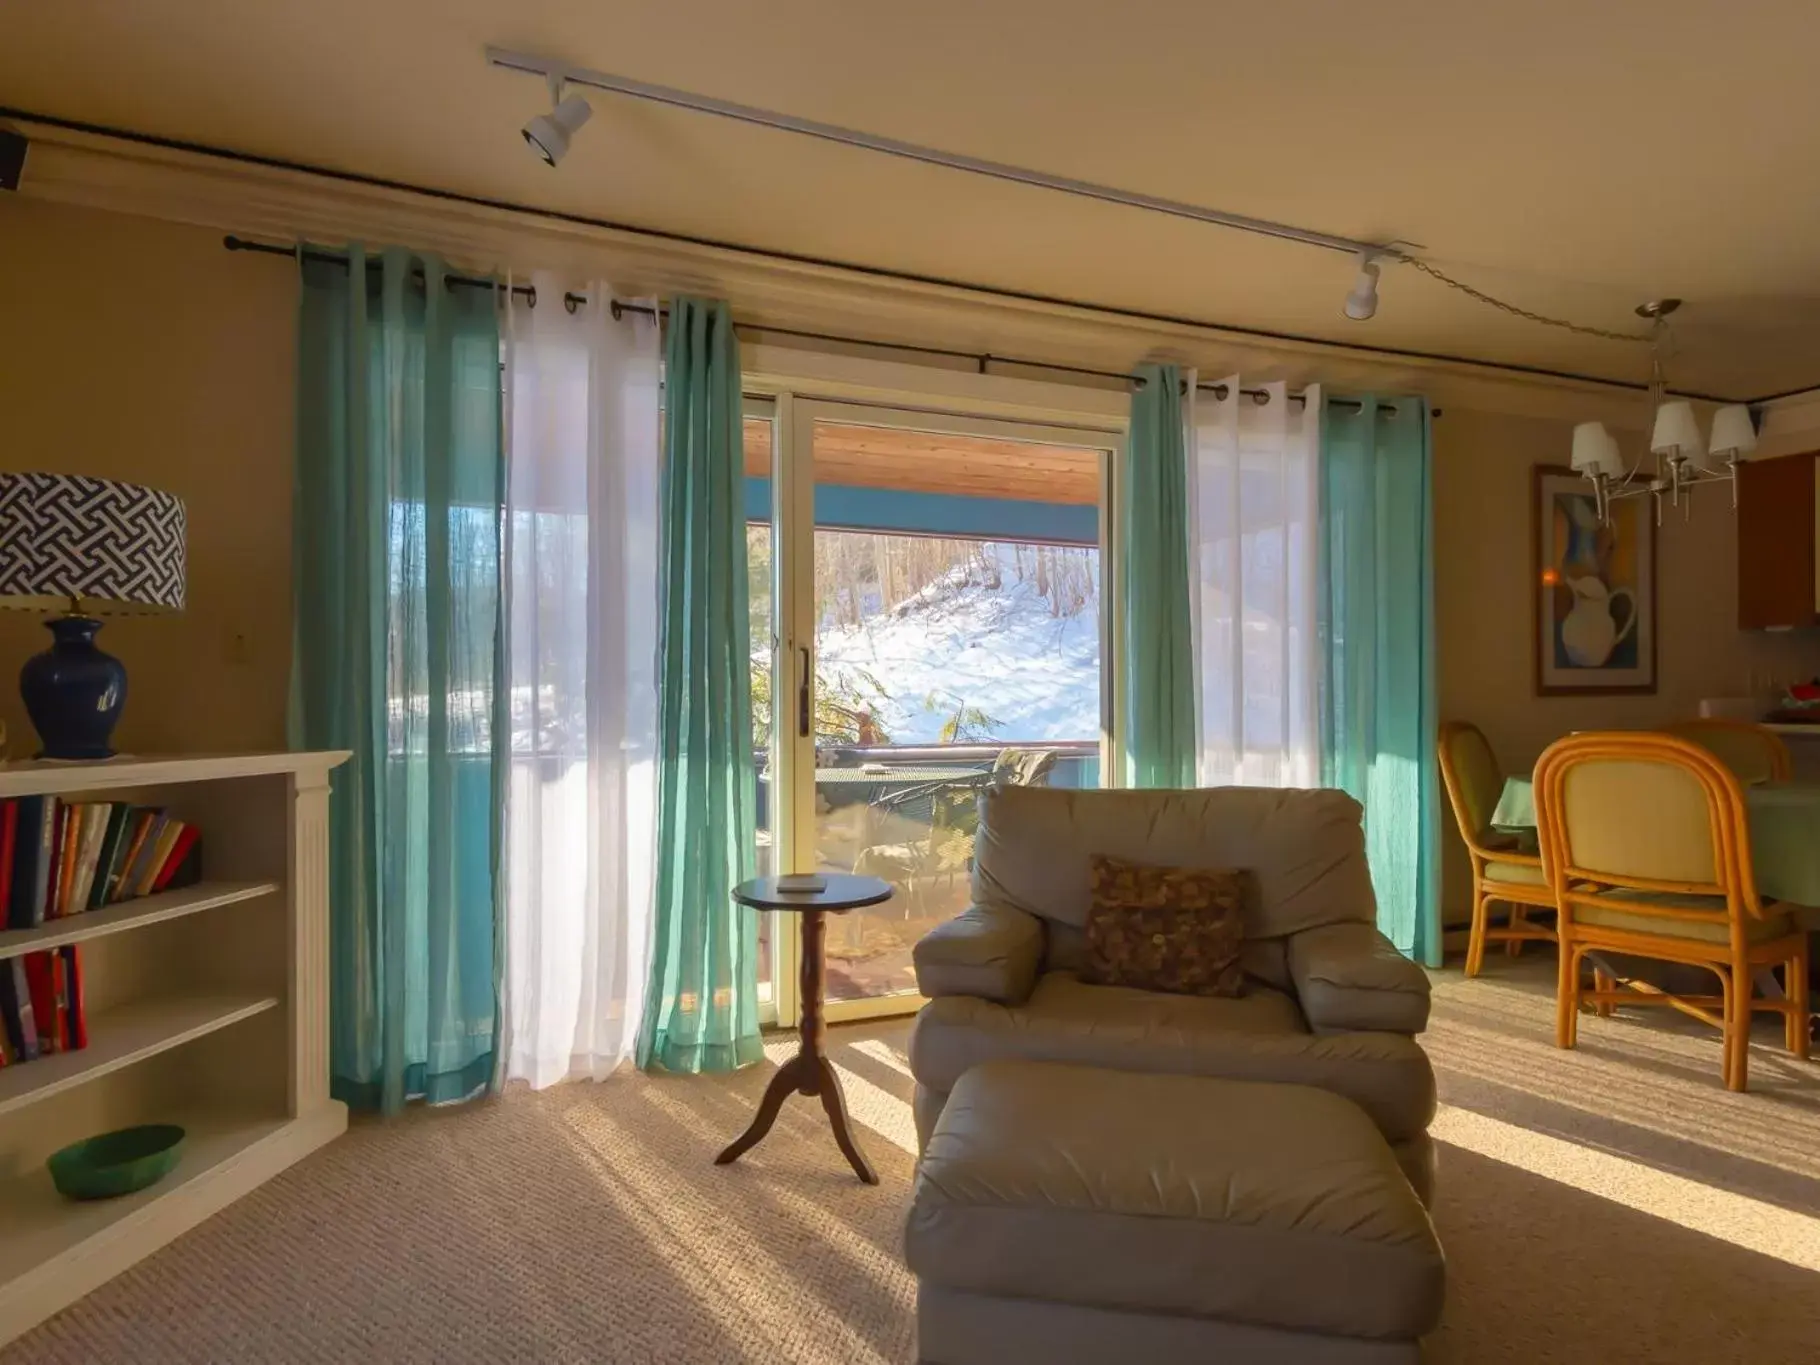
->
[1536, 732, 1807, 1090]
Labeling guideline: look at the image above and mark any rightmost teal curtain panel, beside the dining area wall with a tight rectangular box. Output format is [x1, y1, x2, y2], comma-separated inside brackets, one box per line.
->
[1320, 397, 1441, 966]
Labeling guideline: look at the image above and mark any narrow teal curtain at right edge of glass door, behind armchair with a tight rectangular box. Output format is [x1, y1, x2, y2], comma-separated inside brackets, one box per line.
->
[1114, 366, 1199, 786]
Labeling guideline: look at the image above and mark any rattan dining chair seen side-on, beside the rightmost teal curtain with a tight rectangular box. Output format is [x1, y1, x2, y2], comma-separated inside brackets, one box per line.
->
[1440, 721, 1554, 976]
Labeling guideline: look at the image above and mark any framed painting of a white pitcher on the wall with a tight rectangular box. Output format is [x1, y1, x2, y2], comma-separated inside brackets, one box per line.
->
[1529, 464, 1660, 697]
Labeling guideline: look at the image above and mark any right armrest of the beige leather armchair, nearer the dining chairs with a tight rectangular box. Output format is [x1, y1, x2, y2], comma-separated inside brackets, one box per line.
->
[1287, 923, 1429, 1034]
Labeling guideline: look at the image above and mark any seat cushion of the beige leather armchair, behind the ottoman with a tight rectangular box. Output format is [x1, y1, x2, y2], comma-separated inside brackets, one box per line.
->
[910, 972, 1434, 1143]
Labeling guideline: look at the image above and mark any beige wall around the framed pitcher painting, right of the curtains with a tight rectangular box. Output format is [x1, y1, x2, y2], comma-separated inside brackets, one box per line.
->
[1434, 406, 1820, 919]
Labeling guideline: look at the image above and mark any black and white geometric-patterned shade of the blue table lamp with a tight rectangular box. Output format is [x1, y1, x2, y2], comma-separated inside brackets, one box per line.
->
[0, 473, 184, 615]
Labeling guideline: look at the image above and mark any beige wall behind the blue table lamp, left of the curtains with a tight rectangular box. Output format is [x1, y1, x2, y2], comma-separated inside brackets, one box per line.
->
[0, 195, 295, 757]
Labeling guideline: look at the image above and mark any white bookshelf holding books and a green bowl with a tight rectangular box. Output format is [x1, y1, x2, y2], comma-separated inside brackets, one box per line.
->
[0, 753, 348, 1345]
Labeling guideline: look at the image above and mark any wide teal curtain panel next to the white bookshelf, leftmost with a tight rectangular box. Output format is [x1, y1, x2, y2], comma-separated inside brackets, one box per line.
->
[291, 248, 508, 1114]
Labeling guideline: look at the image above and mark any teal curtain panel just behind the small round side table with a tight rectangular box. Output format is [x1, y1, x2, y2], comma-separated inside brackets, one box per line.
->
[639, 298, 764, 1072]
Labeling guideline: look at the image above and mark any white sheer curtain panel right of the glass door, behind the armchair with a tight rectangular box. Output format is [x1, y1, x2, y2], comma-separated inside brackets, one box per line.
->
[1185, 375, 1323, 786]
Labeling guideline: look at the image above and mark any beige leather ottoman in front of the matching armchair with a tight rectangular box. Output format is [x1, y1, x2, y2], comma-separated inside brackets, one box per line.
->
[905, 1061, 1445, 1365]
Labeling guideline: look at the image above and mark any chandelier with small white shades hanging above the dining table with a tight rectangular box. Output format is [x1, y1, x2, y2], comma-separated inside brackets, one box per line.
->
[1572, 298, 1756, 526]
